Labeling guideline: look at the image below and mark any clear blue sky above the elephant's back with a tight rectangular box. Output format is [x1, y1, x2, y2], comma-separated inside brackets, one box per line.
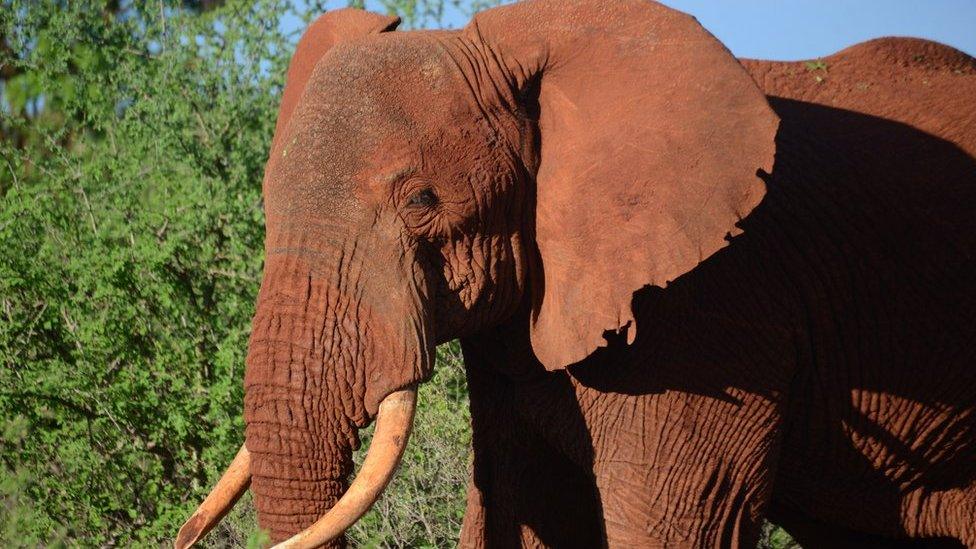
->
[300, 0, 976, 60]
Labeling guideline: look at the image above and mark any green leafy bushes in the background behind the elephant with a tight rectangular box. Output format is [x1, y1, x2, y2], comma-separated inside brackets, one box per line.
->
[0, 0, 790, 547]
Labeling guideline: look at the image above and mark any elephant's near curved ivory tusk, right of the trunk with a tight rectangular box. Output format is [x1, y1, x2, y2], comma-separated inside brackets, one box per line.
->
[273, 387, 417, 549]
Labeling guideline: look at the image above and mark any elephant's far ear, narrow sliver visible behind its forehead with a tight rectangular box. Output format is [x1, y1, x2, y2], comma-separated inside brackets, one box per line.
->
[271, 8, 400, 158]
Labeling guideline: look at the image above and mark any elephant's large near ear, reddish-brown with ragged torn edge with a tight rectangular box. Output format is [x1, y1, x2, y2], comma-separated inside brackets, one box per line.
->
[465, 0, 779, 370]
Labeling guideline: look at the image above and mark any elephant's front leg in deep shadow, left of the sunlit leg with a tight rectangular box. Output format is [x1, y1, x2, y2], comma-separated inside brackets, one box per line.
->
[461, 317, 606, 547]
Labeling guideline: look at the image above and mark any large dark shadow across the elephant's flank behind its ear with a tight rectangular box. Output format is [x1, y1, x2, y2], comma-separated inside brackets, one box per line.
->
[465, 97, 976, 543]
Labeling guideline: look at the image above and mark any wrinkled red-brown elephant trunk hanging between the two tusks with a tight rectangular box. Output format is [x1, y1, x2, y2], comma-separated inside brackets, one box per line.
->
[244, 258, 365, 542]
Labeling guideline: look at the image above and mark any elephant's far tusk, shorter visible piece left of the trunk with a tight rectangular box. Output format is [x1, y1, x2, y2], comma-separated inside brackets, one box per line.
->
[173, 444, 251, 549]
